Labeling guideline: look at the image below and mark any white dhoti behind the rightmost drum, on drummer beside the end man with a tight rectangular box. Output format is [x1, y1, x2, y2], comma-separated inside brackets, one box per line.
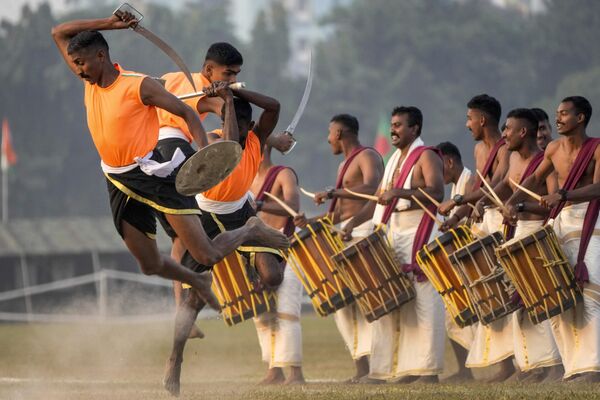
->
[512, 220, 561, 372]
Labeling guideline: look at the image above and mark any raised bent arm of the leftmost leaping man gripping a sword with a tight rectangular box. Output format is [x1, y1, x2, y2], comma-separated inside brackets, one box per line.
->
[52, 13, 138, 75]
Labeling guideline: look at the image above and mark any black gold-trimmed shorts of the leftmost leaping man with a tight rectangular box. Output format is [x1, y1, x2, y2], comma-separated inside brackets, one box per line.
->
[104, 148, 201, 238]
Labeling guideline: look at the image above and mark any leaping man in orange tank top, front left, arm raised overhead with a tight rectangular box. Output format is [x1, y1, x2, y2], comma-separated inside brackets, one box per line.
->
[52, 13, 288, 308]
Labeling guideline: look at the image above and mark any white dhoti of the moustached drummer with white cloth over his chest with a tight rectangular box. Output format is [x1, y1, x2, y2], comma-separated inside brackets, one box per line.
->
[369, 210, 446, 379]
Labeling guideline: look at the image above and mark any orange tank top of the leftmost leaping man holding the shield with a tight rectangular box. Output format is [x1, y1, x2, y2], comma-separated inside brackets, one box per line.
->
[84, 64, 158, 167]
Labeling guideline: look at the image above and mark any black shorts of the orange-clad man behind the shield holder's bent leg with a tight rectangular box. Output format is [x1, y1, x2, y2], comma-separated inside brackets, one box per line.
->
[181, 201, 283, 272]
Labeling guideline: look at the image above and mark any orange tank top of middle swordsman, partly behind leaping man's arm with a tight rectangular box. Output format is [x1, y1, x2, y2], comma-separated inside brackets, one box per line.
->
[156, 72, 210, 143]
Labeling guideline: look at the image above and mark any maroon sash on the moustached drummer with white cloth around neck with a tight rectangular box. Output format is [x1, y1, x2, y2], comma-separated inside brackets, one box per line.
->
[381, 146, 442, 282]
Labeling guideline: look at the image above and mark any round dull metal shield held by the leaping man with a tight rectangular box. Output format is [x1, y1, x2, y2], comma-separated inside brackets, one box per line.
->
[175, 140, 242, 196]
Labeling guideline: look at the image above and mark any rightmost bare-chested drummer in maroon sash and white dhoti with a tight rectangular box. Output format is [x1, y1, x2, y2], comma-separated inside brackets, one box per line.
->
[508, 96, 600, 382]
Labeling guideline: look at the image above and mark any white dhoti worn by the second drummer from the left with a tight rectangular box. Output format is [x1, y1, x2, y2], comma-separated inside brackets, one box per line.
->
[333, 221, 373, 360]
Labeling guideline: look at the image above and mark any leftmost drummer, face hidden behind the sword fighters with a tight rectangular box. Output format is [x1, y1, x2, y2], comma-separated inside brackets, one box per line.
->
[251, 145, 305, 385]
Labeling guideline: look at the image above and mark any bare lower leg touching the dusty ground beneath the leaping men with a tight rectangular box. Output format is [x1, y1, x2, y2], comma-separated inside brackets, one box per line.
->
[163, 288, 210, 396]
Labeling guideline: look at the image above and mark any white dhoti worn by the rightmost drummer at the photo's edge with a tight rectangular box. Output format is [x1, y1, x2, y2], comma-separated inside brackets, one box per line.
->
[551, 203, 600, 378]
